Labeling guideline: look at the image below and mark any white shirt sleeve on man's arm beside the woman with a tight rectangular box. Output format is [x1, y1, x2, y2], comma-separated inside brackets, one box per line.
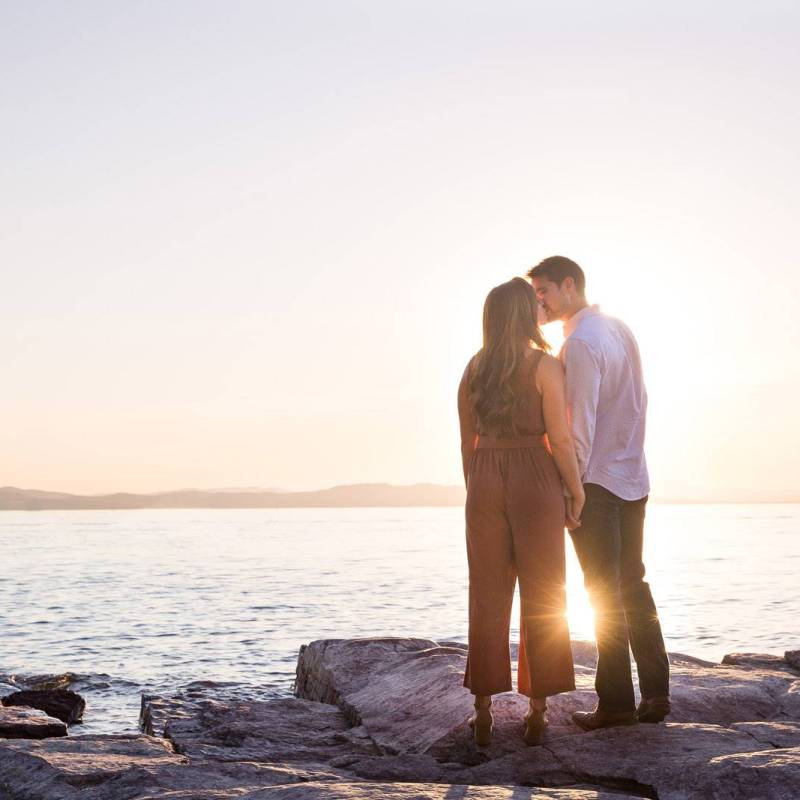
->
[564, 337, 601, 478]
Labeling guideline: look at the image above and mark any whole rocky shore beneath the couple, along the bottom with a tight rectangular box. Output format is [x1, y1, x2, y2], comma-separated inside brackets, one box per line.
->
[0, 639, 800, 800]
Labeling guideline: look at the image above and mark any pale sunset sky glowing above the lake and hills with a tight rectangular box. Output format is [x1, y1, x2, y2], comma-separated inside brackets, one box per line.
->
[0, 0, 800, 500]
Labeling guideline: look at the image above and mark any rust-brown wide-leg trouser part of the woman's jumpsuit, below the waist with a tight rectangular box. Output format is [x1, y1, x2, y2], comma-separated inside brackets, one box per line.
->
[464, 437, 575, 697]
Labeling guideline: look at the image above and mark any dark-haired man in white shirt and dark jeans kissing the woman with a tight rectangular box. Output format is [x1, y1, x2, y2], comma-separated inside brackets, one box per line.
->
[528, 256, 670, 730]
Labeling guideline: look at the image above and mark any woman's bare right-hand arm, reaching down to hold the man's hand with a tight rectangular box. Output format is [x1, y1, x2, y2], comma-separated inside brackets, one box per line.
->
[536, 355, 585, 528]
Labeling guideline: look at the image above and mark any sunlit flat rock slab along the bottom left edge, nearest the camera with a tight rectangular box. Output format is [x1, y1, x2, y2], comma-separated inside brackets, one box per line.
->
[0, 735, 624, 800]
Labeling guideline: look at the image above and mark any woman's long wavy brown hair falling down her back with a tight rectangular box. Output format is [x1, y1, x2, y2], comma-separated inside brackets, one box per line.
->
[468, 278, 550, 437]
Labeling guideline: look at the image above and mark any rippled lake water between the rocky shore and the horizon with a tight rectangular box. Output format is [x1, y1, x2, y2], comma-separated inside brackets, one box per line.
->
[0, 504, 800, 732]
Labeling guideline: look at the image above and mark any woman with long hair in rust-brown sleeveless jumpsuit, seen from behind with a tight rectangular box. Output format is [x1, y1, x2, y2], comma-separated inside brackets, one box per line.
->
[458, 278, 584, 746]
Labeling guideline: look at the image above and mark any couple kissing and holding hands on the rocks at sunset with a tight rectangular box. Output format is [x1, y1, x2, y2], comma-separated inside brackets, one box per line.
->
[458, 256, 670, 746]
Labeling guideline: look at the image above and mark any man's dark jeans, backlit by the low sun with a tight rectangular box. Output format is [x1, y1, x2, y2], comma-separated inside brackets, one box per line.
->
[572, 483, 669, 712]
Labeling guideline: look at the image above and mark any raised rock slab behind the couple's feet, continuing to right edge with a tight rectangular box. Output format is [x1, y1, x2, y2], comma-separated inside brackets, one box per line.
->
[296, 639, 800, 764]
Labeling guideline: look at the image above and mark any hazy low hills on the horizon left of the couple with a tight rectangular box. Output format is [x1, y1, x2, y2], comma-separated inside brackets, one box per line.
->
[0, 483, 465, 511]
